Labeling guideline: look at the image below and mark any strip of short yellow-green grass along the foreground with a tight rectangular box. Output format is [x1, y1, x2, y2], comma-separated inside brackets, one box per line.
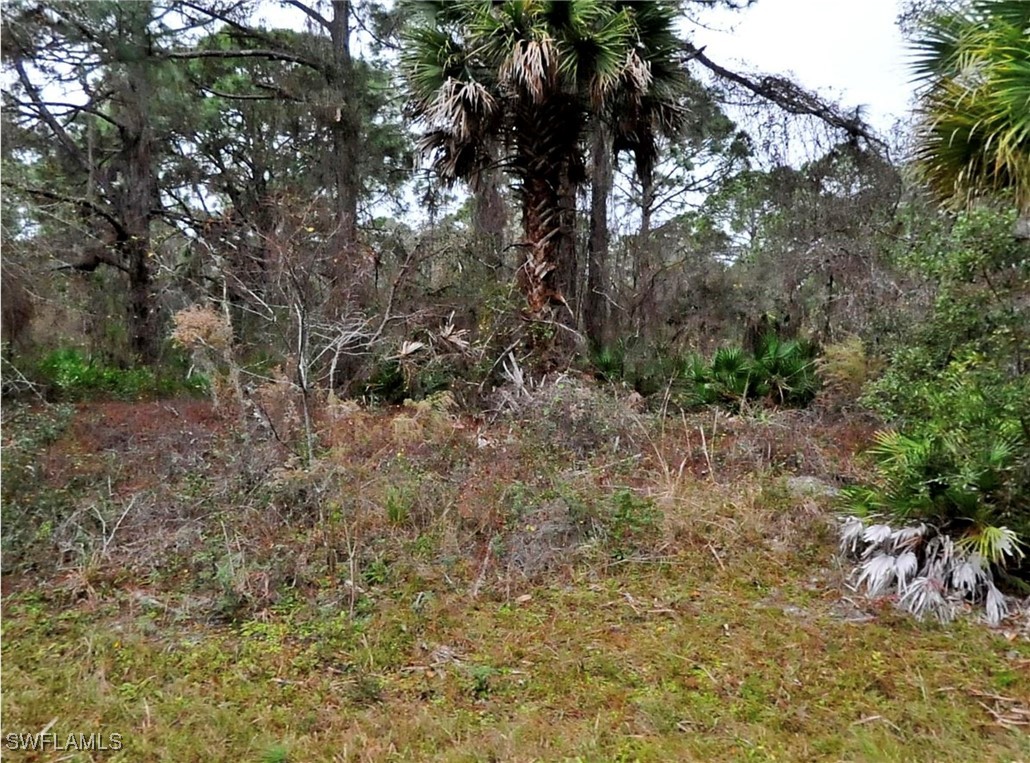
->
[3, 558, 1030, 761]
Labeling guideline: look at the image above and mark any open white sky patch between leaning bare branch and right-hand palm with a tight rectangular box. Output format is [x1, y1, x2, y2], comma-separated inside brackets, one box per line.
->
[688, 0, 913, 133]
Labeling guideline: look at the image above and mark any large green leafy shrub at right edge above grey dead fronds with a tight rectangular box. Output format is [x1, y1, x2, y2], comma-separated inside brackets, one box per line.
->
[845, 204, 1030, 580]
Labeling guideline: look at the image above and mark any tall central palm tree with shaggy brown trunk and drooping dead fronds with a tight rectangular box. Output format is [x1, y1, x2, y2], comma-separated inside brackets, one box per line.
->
[403, 0, 679, 319]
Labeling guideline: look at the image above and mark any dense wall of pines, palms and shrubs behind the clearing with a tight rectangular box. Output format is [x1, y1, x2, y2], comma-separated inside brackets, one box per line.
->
[0, 0, 1030, 597]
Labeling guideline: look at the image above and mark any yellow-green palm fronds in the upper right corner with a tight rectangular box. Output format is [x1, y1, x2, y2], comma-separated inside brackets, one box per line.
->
[914, 0, 1030, 213]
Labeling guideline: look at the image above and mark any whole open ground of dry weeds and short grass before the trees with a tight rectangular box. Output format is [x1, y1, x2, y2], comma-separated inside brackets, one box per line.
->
[3, 395, 1030, 761]
